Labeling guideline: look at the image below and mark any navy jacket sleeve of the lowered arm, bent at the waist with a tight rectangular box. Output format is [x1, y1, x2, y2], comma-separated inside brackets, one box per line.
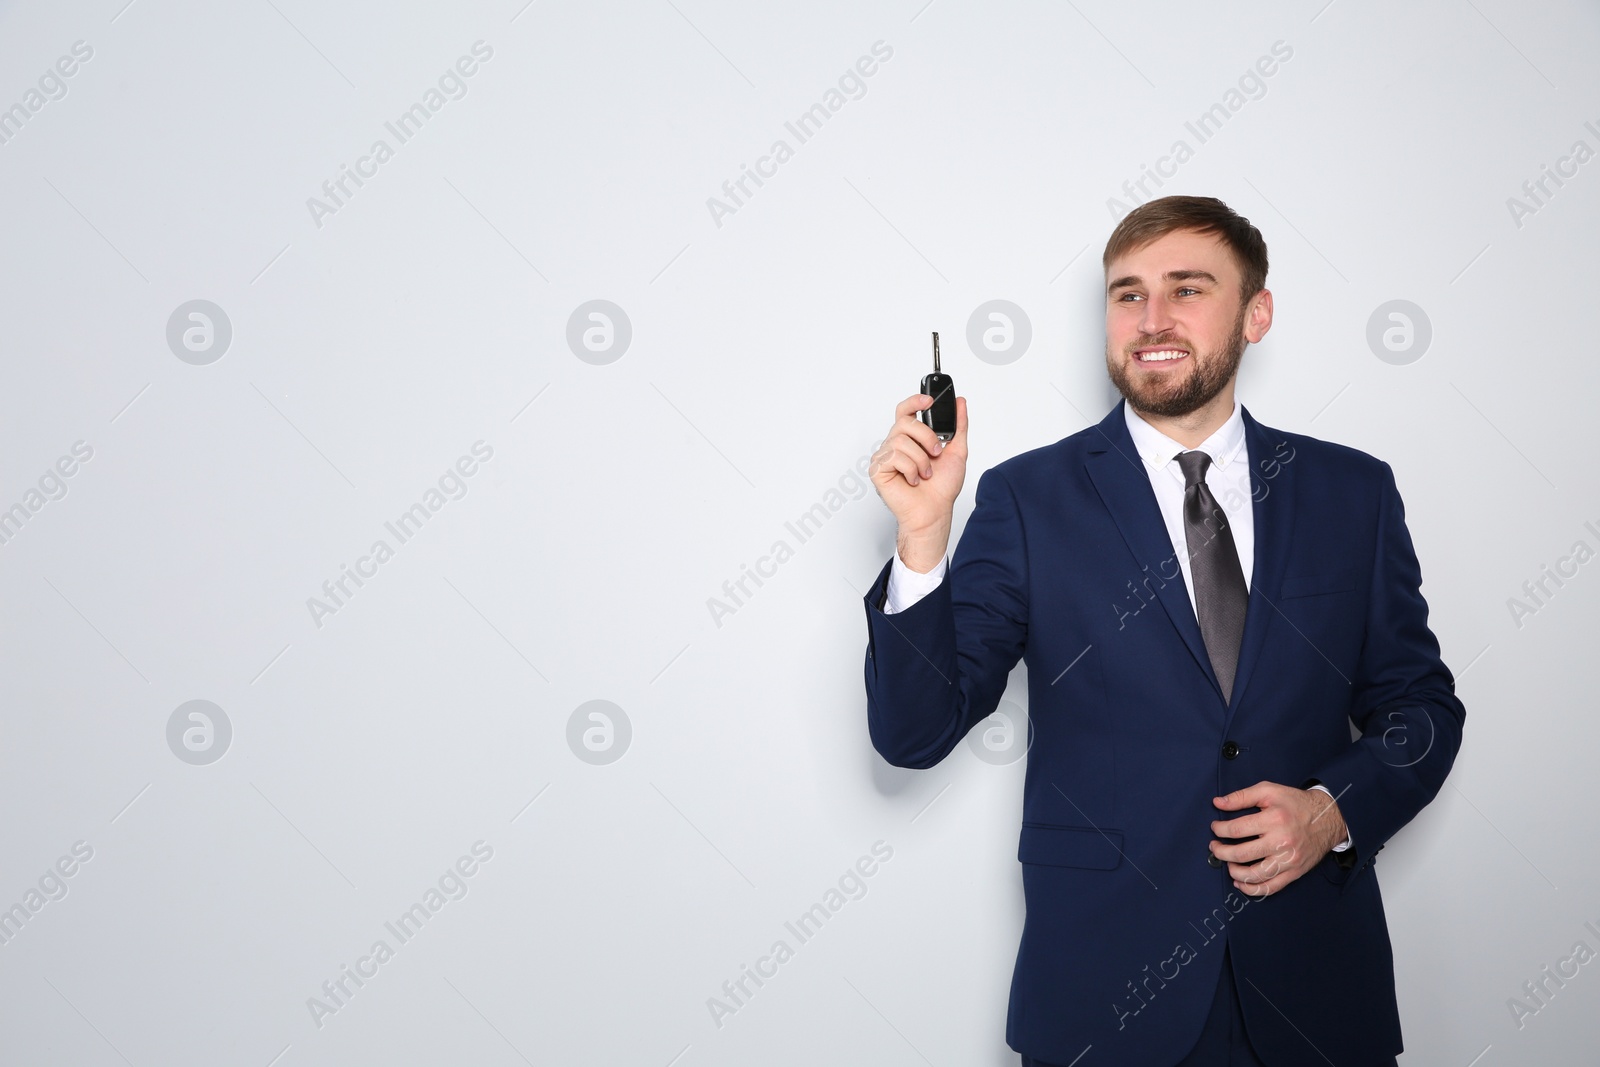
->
[1310, 464, 1467, 877]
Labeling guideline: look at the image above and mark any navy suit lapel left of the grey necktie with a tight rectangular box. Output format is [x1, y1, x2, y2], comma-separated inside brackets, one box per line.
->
[1083, 402, 1216, 701]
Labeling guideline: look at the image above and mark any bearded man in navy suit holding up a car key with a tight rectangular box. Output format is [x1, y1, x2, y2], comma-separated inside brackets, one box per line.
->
[866, 197, 1466, 1067]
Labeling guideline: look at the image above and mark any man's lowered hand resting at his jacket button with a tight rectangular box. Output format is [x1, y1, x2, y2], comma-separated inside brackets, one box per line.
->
[1211, 782, 1347, 897]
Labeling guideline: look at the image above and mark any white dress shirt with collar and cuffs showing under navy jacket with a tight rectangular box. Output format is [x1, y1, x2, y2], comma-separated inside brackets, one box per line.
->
[883, 398, 1350, 853]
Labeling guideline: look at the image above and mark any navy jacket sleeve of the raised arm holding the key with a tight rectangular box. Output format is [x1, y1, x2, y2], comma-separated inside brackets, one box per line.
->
[864, 469, 1027, 768]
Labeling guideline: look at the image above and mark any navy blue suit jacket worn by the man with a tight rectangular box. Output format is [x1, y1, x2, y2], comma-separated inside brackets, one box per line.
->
[866, 405, 1466, 1067]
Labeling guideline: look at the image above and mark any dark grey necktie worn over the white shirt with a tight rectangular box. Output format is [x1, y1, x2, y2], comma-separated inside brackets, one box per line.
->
[1178, 451, 1250, 701]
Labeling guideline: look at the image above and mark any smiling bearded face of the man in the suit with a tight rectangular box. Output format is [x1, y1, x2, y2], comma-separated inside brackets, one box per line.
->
[1106, 230, 1272, 418]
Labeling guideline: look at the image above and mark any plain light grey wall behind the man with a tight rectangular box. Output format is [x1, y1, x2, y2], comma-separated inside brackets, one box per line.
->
[0, 0, 1600, 1067]
